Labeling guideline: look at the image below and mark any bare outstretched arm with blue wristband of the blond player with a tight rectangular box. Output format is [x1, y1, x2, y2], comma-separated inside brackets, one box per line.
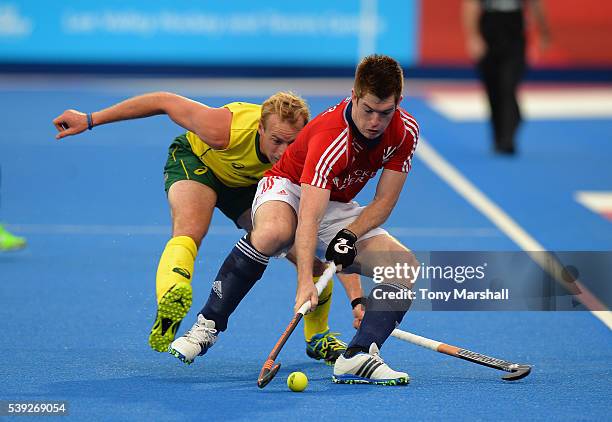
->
[53, 92, 232, 149]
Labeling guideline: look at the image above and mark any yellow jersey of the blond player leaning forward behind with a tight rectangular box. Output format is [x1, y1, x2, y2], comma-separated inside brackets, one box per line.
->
[186, 102, 272, 188]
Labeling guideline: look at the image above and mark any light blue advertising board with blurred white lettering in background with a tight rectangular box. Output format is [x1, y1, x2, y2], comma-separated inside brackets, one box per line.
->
[0, 0, 418, 66]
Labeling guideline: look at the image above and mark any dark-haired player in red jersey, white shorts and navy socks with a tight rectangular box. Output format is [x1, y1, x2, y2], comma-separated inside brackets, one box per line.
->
[173, 55, 419, 385]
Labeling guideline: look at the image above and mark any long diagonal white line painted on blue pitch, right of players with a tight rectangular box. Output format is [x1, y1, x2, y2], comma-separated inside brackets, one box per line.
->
[417, 138, 612, 329]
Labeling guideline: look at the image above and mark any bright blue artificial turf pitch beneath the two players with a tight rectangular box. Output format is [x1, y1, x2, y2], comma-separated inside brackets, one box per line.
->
[0, 81, 612, 420]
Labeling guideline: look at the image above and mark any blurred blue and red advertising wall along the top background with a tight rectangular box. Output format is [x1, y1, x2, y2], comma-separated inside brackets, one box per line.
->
[0, 0, 612, 80]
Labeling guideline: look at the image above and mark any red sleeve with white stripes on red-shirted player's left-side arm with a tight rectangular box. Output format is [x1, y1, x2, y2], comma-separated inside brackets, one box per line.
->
[300, 128, 348, 190]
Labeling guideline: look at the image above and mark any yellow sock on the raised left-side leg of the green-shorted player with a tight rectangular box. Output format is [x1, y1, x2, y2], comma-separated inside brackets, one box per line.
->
[156, 236, 198, 303]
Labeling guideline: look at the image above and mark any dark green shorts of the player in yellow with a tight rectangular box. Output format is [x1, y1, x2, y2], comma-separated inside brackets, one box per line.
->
[164, 135, 257, 227]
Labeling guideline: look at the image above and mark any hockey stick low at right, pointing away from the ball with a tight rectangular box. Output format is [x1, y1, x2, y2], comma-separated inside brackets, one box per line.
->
[391, 328, 531, 381]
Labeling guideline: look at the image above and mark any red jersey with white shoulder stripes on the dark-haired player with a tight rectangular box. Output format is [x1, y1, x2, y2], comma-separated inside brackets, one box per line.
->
[265, 97, 419, 202]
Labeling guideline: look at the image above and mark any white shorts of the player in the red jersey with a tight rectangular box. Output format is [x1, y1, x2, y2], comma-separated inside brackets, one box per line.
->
[251, 176, 388, 260]
